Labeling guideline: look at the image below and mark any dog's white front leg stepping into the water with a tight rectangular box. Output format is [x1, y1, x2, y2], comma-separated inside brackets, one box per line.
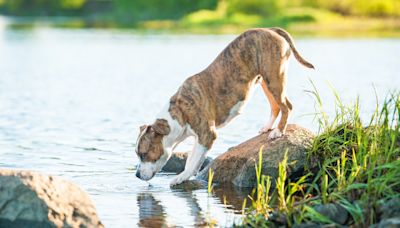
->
[171, 142, 208, 186]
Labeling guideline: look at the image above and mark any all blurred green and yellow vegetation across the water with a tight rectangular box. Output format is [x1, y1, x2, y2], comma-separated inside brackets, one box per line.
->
[0, 0, 400, 36]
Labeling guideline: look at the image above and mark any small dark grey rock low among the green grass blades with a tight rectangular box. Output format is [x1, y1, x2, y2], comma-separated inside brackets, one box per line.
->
[314, 203, 349, 225]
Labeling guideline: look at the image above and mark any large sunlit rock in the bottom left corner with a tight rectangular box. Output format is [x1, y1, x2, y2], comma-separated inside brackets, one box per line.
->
[0, 169, 104, 227]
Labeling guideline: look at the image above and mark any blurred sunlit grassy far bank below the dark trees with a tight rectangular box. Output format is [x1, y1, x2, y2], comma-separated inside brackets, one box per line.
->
[0, 7, 400, 38]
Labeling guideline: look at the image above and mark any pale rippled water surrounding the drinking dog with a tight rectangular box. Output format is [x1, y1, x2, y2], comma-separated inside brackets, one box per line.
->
[0, 23, 400, 227]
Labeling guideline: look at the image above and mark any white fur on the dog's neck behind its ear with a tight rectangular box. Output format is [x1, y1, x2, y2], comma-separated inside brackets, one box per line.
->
[157, 103, 187, 152]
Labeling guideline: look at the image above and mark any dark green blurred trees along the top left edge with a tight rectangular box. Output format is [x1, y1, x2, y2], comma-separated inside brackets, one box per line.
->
[0, 0, 217, 21]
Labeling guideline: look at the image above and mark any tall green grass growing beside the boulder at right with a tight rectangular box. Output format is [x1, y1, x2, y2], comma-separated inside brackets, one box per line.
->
[239, 87, 400, 227]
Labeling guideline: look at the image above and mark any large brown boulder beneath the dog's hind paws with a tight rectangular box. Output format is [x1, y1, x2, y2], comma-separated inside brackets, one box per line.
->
[198, 124, 314, 187]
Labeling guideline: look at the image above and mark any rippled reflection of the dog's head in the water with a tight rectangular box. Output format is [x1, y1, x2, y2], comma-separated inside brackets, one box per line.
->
[137, 193, 167, 227]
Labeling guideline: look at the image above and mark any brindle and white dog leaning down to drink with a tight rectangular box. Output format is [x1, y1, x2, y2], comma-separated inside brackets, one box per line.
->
[136, 28, 314, 185]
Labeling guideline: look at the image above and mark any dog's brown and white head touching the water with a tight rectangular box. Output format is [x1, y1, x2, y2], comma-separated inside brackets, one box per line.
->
[136, 119, 170, 180]
